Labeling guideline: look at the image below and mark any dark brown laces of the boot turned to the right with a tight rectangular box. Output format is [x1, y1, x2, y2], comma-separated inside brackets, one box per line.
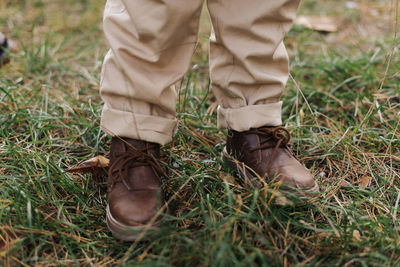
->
[249, 127, 290, 178]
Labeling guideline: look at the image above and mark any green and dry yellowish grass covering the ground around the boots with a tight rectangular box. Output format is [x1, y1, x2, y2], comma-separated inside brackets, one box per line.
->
[0, 0, 400, 266]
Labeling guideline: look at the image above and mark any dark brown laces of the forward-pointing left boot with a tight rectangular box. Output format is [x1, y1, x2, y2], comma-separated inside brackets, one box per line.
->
[108, 148, 163, 190]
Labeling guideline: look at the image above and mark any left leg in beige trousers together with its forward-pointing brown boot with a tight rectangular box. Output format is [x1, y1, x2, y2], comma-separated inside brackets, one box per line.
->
[100, 0, 203, 240]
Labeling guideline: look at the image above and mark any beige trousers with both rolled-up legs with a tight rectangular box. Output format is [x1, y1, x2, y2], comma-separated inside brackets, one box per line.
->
[100, 0, 299, 144]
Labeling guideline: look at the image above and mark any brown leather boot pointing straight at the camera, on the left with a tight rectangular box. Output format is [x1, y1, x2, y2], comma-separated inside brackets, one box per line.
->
[107, 137, 164, 241]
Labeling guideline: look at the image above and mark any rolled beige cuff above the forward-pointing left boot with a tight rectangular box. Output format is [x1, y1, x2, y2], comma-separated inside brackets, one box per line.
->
[100, 105, 178, 145]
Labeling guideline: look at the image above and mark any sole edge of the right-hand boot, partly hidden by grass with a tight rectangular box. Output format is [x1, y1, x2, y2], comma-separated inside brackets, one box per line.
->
[221, 147, 319, 196]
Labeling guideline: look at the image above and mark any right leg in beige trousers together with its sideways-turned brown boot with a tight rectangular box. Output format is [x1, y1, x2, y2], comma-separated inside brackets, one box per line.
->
[208, 0, 317, 193]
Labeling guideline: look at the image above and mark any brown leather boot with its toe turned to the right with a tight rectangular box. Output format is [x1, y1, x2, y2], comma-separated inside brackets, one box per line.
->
[223, 127, 319, 193]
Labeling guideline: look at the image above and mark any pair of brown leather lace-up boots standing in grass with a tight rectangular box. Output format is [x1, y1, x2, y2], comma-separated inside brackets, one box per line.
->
[106, 127, 319, 241]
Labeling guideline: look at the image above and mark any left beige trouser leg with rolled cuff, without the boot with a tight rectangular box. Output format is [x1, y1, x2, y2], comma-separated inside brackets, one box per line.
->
[100, 0, 203, 144]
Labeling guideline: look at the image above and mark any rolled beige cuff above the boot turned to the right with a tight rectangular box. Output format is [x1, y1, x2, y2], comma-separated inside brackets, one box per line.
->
[218, 101, 282, 132]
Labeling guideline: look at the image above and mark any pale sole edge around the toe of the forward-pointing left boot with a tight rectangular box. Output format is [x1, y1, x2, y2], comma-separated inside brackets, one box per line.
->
[106, 205, 158, 241]
